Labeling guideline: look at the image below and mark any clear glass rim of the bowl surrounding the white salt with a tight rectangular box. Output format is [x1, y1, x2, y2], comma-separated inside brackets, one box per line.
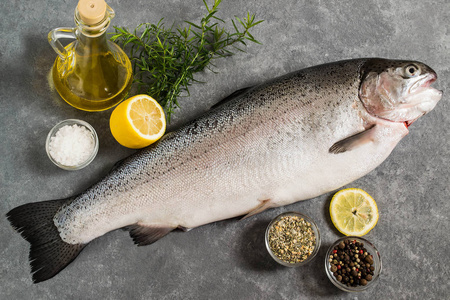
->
[45, 119, 99, 171]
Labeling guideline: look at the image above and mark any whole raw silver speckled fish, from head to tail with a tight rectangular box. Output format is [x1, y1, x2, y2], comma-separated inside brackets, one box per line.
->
[7, 58, 442, 282]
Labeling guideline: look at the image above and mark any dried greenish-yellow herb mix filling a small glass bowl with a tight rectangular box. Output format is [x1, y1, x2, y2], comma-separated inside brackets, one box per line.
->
[269, 216, 316, 264]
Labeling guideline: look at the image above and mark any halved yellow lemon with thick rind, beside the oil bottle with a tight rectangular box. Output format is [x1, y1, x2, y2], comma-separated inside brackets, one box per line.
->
[109, 95, 166, 149]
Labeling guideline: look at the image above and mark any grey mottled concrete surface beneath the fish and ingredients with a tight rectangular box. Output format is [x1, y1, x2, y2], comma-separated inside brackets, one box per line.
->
[0, 0, 450, 299]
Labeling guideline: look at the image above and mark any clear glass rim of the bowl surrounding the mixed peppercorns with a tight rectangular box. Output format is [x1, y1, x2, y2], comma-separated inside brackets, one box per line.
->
[325, 236, 381, 292]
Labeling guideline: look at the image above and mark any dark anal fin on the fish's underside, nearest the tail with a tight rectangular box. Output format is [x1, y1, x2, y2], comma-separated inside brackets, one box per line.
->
[125, 223, 176, 246]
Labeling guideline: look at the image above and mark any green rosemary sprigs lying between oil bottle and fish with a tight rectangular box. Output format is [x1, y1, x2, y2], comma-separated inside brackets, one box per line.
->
[111, 0, 263, 122]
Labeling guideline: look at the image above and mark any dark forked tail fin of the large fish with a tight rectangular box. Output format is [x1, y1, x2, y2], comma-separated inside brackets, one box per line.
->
[6, 198, 85, 283]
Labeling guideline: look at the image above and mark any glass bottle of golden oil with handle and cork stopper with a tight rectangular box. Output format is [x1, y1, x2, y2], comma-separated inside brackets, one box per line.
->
[48, 0, 133, 111]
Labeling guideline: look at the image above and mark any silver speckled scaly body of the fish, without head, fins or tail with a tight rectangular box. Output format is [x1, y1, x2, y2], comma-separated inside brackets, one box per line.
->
[54, 60, 402, 243]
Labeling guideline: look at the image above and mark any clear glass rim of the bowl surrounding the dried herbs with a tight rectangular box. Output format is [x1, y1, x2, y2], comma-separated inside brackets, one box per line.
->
[265, 211, 320, 267]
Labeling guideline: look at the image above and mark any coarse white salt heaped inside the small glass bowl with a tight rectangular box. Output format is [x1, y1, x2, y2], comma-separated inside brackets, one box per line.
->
[49, 124, 95, 167]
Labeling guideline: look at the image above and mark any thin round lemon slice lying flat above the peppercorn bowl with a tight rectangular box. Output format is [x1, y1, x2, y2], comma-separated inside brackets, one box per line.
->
[330, 188, 378, 236]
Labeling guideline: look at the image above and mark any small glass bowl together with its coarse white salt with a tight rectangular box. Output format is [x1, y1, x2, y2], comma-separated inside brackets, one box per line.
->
[45, 119, 98, 170]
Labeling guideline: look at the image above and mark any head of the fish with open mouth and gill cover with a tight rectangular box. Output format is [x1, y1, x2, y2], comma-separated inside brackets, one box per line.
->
[359, 59, 442, 127]
